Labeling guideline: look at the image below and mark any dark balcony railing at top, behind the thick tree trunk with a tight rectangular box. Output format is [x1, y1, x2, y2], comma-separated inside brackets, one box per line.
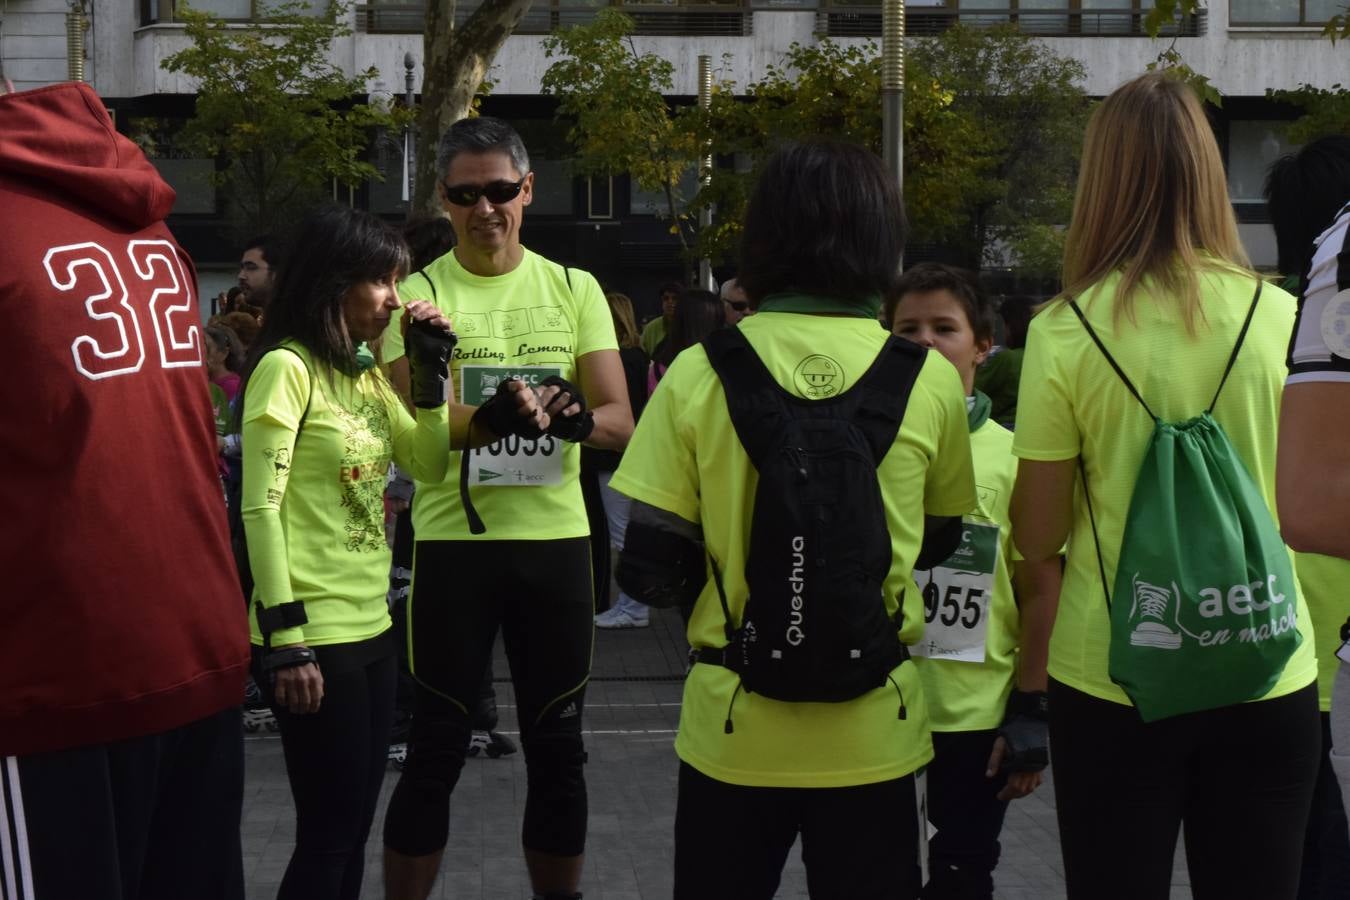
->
[356, 3, 753, 36]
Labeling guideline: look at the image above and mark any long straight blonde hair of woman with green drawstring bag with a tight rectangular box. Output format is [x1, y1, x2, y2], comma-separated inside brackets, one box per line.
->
[1064, 73, 1251, 333]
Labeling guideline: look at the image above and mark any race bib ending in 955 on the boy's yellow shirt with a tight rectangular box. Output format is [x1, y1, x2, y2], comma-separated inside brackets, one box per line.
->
[910, 522, 999, 663]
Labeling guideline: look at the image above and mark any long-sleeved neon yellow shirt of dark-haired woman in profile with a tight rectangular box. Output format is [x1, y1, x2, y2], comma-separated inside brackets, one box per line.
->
[240, 343, 450, 646]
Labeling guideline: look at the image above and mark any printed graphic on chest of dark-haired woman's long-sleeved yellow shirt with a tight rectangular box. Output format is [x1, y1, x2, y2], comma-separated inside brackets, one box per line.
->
[332, 402, 393, 553]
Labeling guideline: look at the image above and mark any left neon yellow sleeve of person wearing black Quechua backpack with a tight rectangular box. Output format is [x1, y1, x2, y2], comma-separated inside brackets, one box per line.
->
[610, 348, 702, 525]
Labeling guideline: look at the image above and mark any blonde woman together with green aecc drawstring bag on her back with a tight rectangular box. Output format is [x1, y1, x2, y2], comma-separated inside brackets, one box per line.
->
[1013, 73, 1320, 900]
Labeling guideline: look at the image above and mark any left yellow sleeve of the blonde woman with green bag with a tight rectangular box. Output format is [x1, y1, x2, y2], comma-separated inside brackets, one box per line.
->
[1013, 309, 1083, 463]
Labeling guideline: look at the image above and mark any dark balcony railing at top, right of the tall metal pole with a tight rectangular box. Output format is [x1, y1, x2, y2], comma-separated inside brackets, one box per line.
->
[815, 0, 1207, 38]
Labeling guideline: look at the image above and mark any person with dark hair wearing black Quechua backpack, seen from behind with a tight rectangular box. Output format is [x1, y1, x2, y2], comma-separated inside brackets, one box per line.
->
[612, 142, 976, 900]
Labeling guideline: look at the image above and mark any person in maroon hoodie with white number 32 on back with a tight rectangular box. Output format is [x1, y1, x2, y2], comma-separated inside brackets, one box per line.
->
[0, 84, 248, 900]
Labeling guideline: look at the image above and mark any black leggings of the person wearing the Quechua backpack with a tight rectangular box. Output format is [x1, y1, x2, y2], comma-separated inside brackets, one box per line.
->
[675, 762, 919, 900]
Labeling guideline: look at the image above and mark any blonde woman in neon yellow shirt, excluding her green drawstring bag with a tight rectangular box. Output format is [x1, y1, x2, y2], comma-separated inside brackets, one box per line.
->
[1013, 74, 1320, 900]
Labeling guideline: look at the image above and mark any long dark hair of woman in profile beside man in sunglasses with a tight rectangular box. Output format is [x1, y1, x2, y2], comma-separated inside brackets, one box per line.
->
[239, 206, 409, 409]
